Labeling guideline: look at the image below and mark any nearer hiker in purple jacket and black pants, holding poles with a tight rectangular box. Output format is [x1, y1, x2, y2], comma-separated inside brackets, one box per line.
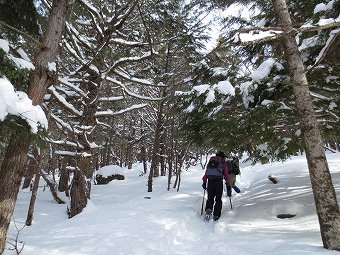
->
[202, 151, 231, 221]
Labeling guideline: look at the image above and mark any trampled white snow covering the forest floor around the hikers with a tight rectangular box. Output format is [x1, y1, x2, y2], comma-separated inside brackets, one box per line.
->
[4, 153, 340, 255]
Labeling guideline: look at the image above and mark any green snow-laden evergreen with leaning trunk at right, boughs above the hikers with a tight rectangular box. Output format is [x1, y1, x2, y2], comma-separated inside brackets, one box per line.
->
[174, 0, 340, 250]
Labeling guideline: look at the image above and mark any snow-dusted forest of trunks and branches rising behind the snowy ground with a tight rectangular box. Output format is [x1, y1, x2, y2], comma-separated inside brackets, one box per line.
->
[0, 0, 340, 253]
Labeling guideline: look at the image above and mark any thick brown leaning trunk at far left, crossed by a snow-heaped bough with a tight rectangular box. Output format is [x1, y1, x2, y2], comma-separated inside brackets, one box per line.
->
[0, 0, 70, 251]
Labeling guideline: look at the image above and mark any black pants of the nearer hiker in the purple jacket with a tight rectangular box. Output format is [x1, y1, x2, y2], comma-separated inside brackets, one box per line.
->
[205, 179, 223, 217]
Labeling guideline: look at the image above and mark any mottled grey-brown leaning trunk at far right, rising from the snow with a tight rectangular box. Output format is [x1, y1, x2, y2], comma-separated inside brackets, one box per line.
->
[272, 0, 340, 251]
